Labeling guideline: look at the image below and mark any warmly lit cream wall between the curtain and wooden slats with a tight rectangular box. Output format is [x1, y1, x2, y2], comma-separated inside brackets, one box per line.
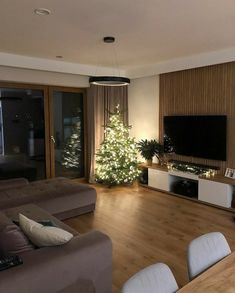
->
[128, 76, 159, 161]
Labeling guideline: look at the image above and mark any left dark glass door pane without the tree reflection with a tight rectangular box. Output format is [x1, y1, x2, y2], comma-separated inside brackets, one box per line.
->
[0, 88, 46, 181]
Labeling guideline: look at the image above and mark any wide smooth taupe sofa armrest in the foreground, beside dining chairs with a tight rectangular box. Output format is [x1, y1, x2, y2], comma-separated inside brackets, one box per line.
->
[0, 231, 112, 293]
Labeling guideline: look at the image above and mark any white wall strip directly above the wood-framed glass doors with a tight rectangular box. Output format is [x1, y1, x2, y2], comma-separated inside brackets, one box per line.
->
[0, 66, 89, 87]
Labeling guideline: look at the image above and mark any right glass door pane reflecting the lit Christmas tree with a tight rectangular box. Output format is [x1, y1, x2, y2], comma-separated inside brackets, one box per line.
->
[51, 90, 84, 178]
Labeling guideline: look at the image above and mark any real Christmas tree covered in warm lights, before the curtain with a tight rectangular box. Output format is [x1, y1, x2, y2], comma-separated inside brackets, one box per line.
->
[96, 105, 140, 186]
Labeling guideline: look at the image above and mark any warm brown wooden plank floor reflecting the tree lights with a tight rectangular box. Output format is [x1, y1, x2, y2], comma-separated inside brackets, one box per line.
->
[66, 185, 235, 293]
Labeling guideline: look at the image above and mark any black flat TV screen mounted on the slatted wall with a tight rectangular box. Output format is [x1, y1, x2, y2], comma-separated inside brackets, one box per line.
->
[164, 115, 227, 161]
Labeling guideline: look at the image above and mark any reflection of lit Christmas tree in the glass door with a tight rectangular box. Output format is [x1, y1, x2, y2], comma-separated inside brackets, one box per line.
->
[62, 123, 82, 168]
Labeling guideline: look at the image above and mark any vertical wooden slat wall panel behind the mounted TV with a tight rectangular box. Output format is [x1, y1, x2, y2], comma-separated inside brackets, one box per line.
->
[159, 62, 235, 173]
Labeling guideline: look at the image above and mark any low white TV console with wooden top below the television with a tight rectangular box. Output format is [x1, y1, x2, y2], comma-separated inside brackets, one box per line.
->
[148, 164, 235, 208]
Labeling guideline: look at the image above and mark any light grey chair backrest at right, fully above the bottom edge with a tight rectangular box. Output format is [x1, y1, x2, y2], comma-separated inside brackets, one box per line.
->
[187, 232, 231, 280]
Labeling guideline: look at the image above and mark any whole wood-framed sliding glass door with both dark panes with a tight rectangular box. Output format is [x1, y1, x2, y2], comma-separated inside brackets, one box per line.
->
[0, 82, 85, 181]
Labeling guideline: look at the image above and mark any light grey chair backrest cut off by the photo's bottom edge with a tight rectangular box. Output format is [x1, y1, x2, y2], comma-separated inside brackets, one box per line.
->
[122, 263, 179, 293]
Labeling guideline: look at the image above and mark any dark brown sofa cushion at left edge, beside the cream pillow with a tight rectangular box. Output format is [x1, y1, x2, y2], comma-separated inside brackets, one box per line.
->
[0, 213, 34, 255]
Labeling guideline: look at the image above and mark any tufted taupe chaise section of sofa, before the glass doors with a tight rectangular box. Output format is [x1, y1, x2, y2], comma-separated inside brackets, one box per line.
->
[0, 177, 96, 219]
